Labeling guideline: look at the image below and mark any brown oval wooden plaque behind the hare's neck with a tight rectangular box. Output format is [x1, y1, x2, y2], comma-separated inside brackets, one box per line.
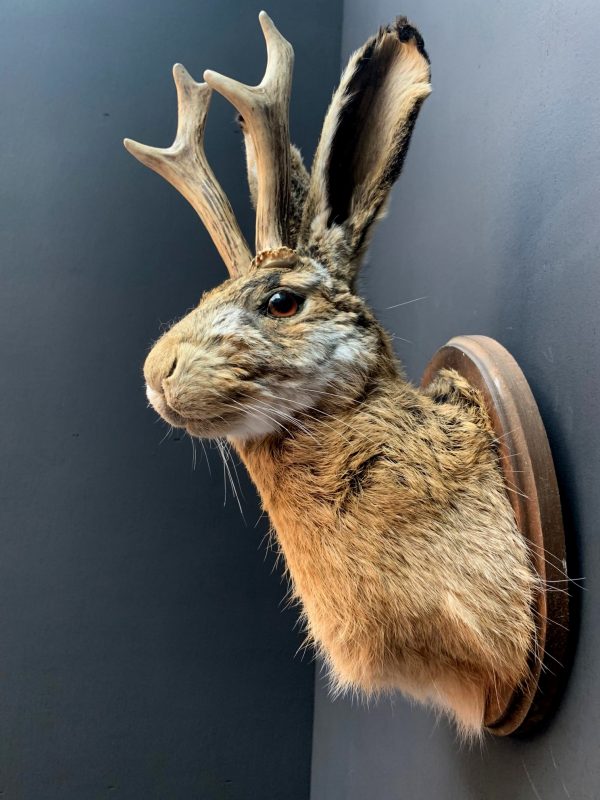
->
[421, 336, 569, 736]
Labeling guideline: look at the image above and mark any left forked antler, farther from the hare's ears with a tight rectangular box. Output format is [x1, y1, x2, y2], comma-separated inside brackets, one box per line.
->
[123, 64, 252, 278]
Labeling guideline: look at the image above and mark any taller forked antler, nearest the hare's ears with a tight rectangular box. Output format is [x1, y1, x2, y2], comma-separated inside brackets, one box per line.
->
[204, 11, 294, 254]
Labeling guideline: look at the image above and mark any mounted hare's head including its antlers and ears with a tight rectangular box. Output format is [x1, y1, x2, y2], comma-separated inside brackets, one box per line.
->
[125, 12, 430, 439]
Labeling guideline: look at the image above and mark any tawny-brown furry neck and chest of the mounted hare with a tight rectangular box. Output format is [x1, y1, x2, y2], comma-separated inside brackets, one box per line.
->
[238, 346, 533, 729]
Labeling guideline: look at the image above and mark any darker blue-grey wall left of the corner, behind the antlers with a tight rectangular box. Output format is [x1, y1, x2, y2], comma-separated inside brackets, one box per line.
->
[0, 0, 341, 800]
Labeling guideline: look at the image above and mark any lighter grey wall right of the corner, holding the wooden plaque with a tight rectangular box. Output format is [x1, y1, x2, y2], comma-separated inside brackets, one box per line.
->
[311, 0, 600, 800]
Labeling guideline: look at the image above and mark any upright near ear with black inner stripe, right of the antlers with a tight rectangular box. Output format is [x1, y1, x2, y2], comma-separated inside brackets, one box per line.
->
[298, 17, 431, 285]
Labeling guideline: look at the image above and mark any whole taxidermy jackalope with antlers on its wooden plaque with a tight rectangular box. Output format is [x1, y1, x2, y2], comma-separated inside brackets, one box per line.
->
[125, 12, 566, 734]
